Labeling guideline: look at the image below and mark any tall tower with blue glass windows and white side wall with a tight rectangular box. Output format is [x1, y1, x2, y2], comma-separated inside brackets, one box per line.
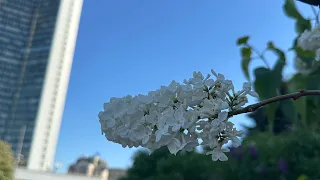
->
[0, 0, 83, 171]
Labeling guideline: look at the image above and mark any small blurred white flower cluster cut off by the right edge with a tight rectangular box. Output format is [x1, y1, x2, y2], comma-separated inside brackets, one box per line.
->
[297, 27, 320, 60]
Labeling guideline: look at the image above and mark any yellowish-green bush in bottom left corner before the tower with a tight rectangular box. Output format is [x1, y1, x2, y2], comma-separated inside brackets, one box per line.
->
[0, 141, 15, 180]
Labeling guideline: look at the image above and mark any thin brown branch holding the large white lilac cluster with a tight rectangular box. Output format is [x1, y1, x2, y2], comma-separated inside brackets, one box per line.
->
[229, 90, 320, 117]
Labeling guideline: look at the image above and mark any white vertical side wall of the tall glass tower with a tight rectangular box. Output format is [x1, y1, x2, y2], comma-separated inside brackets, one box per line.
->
[28, 0, 83, 171]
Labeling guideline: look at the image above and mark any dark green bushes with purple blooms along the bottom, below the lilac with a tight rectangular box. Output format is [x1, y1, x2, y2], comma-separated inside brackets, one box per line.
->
[121, 129, 320, 180]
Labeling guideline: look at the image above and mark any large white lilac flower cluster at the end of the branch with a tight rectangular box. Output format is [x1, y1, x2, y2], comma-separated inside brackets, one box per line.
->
[99, 70, 258, 161]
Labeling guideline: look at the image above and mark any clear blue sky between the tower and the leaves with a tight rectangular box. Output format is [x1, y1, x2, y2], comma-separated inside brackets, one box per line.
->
[56, 0, 310, 172]
